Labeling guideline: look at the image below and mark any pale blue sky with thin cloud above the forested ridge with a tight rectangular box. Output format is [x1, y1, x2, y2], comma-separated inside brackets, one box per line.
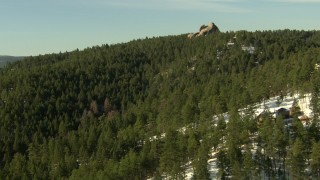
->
[0, 0, 320, 56]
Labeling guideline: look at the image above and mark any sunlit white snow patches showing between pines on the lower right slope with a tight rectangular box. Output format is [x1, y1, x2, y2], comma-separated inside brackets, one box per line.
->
[150, 94, 313, 179]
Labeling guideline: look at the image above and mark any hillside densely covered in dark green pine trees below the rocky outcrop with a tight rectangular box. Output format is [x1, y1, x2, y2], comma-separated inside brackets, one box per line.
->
[0, 30, 320, 179]
